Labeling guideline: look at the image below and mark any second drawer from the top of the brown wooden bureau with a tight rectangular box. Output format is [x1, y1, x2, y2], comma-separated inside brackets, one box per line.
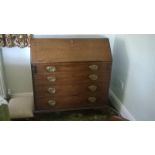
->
[33, 72, 110, 85]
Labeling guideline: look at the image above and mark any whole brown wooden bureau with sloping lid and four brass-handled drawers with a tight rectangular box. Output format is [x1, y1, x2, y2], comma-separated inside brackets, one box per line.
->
[31, 38, 112, 113]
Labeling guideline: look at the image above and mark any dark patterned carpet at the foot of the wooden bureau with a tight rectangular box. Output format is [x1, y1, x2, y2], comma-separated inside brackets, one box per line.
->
[33, 106, 126, 121]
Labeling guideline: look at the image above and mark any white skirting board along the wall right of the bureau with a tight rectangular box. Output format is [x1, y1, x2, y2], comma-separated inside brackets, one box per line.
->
[109, 89, 136, 121]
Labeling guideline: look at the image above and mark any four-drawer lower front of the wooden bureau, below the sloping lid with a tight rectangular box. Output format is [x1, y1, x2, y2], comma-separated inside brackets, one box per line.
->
[32, 62, 111, 110]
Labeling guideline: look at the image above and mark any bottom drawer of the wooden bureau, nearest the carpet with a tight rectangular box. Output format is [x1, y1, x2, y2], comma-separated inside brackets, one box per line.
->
[35, 96, 107, 110]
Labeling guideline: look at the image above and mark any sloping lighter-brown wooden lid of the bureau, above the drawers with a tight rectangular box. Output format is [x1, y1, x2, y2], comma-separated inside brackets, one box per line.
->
[31, 38, 111, 63]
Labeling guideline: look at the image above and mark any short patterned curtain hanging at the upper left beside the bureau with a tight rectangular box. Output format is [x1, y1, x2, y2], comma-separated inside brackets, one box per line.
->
[0, 34, 32, 48]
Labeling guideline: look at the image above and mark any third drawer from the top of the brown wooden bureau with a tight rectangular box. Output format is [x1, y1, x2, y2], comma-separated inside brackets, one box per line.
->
[34, 83, 108, 97]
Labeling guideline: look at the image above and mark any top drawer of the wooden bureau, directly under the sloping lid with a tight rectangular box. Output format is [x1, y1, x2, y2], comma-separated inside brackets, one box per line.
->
[32, 62, 111, 75]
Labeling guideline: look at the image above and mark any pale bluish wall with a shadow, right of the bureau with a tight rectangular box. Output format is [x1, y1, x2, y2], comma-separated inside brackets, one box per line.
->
[111, 35, 155, 120]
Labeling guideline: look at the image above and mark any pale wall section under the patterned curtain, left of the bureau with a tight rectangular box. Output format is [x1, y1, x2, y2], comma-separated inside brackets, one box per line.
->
[2, 47, 32, 94]
